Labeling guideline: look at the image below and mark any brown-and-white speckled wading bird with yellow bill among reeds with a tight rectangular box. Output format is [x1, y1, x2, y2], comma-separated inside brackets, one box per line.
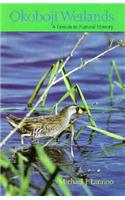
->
[6, 105, 85, 145]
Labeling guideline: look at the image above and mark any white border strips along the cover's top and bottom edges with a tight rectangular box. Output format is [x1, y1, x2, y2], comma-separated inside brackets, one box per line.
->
[0, 0, 125, 200]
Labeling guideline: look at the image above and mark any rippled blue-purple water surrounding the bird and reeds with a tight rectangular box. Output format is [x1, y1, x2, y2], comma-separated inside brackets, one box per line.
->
[1, 33, 125, 195]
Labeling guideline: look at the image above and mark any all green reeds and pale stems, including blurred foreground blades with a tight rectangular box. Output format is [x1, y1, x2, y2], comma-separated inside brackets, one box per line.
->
[0, 33, 125, 195]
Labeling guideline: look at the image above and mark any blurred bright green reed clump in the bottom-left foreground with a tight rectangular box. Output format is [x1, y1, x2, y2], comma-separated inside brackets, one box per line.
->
[0, 145, 71, 196]
